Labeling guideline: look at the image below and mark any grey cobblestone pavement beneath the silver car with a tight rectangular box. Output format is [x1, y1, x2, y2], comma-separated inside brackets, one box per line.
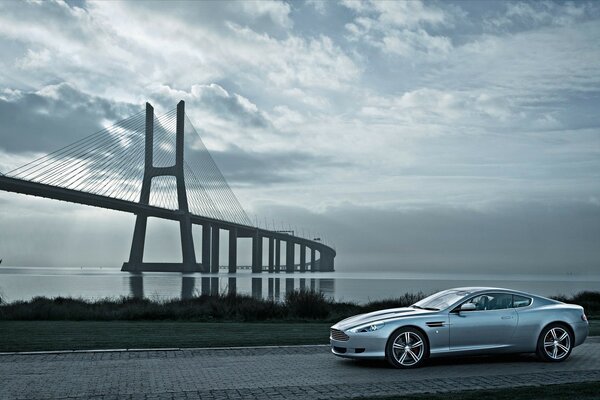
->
[0, 338, 600, 399]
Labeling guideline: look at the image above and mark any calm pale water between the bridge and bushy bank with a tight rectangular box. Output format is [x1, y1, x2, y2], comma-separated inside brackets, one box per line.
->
[0, 266, 600, 303]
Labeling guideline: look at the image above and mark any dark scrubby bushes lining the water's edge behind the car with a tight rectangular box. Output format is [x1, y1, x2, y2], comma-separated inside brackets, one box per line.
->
[0, 290, 600, 322]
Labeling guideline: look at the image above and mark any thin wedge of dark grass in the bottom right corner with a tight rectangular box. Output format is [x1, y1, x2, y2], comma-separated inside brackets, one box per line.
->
[365, 382, 600, 400]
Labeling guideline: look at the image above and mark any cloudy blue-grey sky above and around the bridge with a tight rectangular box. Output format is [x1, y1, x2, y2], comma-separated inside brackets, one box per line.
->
[0, 0, 600, 274]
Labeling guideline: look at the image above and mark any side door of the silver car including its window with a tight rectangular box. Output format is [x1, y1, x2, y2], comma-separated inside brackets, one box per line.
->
[449, 292, 518, 351]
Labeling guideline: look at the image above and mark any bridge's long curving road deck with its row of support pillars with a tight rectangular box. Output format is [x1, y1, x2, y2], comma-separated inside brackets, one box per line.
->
[0, 174, 336, 272]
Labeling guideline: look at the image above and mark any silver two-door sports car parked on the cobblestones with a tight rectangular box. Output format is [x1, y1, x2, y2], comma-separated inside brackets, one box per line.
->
[329, 287, 589, 368]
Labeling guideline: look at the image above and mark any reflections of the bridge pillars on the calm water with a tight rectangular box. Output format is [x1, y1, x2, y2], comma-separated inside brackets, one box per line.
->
[129, 274, 335, 301]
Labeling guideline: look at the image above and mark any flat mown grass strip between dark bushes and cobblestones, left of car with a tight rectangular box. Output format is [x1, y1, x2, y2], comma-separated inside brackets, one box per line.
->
[0, 321, 330, 352]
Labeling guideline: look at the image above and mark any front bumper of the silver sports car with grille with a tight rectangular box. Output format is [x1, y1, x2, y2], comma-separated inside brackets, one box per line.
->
[329, 332, 387, 359]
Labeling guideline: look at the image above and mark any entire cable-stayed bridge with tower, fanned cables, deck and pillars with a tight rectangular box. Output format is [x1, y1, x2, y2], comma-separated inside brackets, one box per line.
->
[0, 101, 336, 273]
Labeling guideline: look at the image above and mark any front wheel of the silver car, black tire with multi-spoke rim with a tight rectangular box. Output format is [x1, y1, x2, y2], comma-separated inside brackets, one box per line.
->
[385, 328, 429, 368]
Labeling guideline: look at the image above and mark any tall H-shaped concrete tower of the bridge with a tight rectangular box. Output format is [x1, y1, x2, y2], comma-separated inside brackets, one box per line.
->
[121, 100, 208, 272]
